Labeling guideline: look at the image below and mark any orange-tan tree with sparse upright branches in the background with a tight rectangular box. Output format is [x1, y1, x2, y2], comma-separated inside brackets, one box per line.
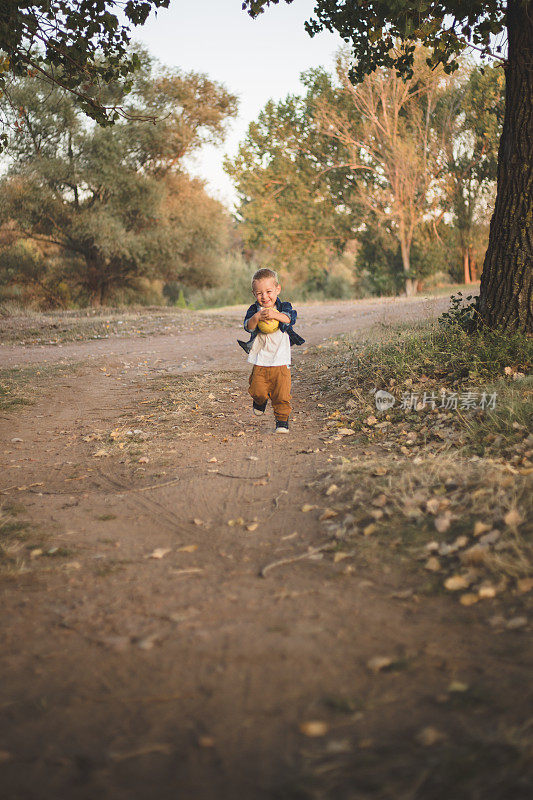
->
[317, 49, 443, 295]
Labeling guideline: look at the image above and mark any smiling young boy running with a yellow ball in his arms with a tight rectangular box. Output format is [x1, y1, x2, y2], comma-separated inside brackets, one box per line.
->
[237, 269, 305, 433]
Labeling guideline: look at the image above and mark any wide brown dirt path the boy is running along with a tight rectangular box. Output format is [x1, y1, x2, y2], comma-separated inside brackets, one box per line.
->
[0, 296, 528, 800]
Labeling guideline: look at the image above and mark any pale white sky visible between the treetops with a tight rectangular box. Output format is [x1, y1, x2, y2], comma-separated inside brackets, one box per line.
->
[134, 0, 342, 207]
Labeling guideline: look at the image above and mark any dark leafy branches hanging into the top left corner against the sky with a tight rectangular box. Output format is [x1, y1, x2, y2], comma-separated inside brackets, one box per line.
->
[0, 0, 169, 131]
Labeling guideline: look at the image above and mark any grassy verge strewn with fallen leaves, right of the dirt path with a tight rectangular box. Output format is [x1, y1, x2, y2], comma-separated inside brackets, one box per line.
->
[308, 325, 533, 605]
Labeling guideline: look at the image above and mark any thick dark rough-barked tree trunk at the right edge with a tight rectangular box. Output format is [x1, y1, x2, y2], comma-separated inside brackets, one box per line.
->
[479, 0, 533, 332]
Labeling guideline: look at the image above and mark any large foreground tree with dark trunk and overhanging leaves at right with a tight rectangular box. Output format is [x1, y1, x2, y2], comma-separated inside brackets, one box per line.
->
[243, 0, 533, 332]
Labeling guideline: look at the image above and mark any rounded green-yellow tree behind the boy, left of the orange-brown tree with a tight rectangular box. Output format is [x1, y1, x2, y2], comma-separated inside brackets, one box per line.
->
[225, 69, 353, 288]
